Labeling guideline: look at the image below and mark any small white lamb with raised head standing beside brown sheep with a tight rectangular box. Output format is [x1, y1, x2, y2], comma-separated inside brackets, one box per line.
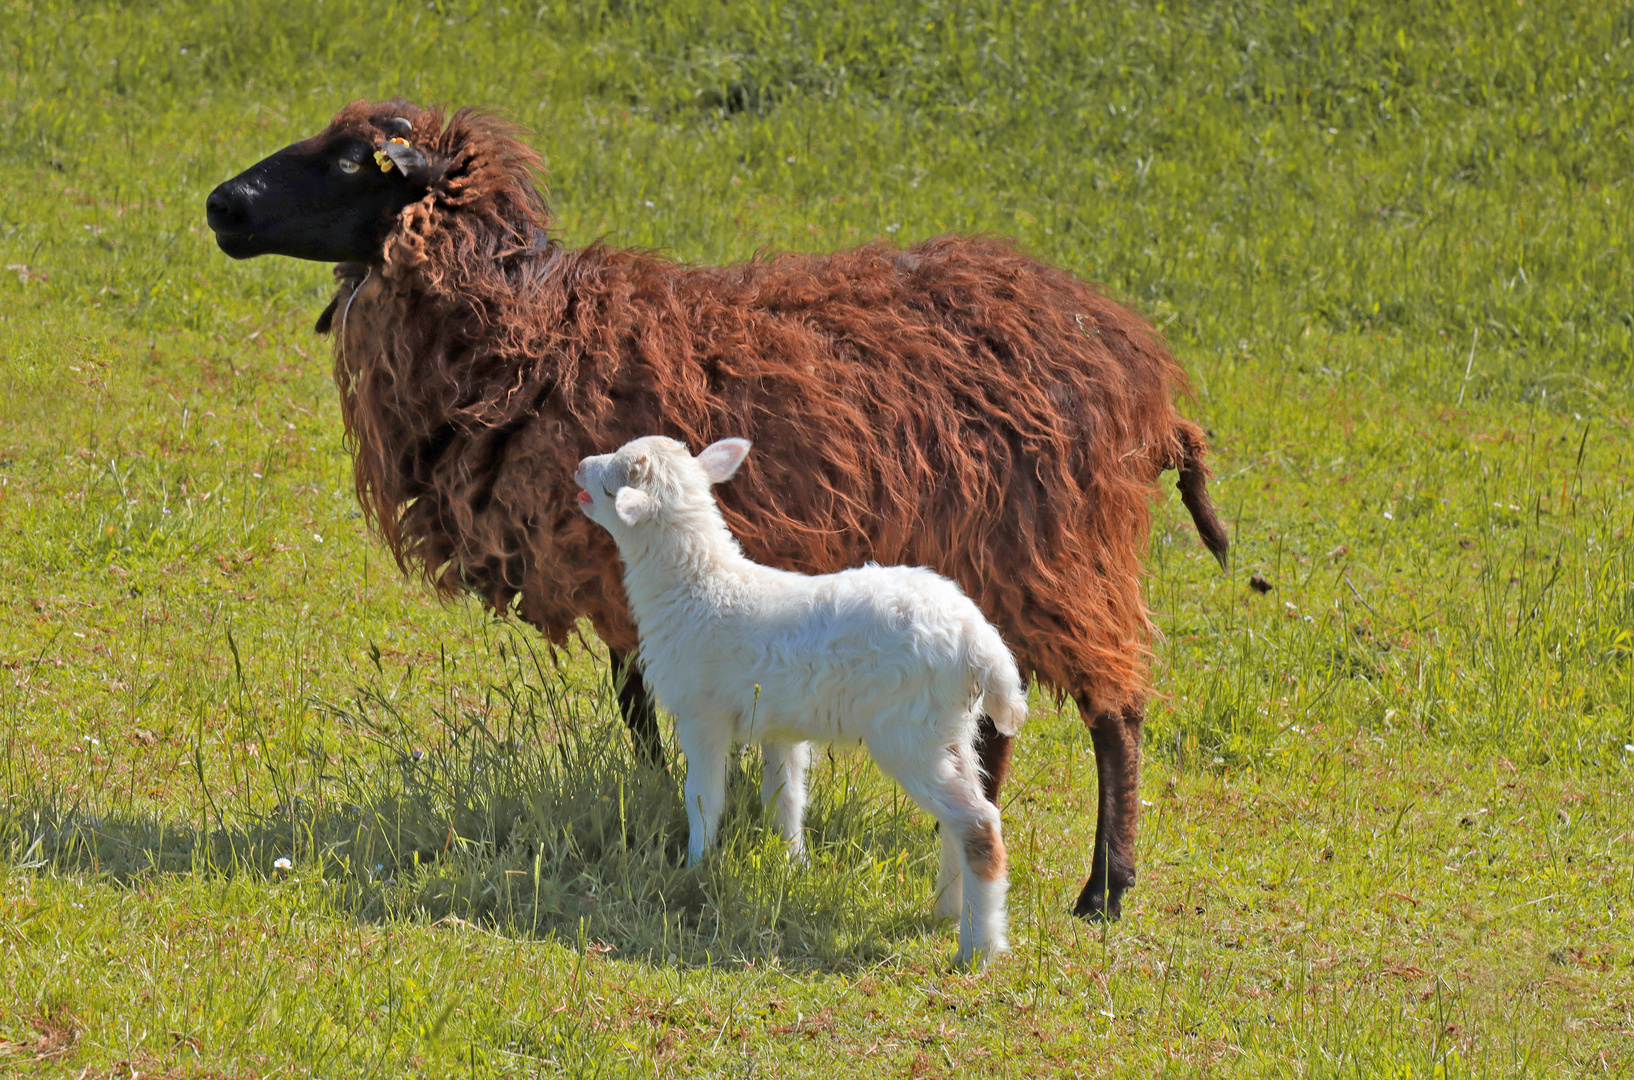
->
[574, 436, 1026, 967]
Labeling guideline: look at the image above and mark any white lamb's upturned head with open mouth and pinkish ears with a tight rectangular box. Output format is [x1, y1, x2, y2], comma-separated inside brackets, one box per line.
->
[574, 435, 748, 544]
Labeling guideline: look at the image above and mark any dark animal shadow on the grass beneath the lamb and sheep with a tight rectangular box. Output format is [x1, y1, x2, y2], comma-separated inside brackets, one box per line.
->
[0, 650, 938, 971]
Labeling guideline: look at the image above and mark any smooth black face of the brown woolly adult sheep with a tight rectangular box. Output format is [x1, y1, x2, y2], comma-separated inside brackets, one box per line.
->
[204, 132, 425, 263]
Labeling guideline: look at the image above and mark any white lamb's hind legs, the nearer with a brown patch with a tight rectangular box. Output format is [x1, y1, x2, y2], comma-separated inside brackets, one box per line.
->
[869, 745, 1010, 967]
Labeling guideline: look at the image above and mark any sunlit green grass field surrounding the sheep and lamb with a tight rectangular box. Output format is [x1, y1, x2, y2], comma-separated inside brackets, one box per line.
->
[0, 0, 1634, 1080]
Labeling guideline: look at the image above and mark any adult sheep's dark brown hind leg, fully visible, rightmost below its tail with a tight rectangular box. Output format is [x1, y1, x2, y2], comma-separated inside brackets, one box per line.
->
[1072, 701, 1142, 923]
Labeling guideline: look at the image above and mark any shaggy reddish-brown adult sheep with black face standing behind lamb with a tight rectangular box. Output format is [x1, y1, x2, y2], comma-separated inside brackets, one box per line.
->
[206, 100, 1226, 918]
